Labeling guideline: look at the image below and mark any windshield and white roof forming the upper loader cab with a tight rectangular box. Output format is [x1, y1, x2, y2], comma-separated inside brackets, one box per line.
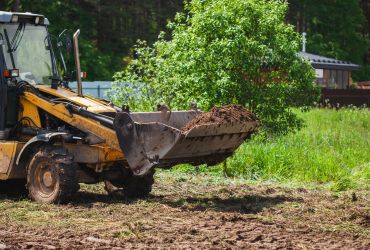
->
[0, 12, 58, 85]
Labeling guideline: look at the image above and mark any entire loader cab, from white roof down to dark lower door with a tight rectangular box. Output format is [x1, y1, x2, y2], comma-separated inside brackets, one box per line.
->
[0, 11, 59, 139]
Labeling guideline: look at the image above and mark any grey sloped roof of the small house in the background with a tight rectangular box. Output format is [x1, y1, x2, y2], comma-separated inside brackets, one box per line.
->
[299, 52, 360, 71]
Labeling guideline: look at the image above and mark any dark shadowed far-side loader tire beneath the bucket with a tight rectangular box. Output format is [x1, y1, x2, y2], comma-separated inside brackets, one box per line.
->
[104, 169, 155, 199]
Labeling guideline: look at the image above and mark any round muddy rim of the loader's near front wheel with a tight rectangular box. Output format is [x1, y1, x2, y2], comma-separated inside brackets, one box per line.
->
[32, 161, 57, 198]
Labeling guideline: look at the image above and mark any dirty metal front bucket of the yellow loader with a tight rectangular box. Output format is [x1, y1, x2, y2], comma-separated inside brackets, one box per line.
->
[114, 111, 259, 175]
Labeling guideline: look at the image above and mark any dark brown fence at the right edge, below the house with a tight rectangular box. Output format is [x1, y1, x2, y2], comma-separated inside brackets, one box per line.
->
[321, 89, 370, 107]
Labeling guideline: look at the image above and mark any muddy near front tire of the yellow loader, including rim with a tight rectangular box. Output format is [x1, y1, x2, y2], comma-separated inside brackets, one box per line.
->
[27, 146, 79, 204]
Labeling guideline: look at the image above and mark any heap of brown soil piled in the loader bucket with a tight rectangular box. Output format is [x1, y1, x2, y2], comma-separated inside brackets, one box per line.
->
[181, 105, 258, 132]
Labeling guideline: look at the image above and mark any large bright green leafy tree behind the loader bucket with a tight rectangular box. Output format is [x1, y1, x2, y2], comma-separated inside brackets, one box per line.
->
[111, 0, 318, 133]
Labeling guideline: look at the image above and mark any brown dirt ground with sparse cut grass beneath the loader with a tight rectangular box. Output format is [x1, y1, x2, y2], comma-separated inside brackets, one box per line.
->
[0, 171, 370, 249]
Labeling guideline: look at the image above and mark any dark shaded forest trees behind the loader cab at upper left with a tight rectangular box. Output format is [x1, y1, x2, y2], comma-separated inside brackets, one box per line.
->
[0, 0, 182, 80]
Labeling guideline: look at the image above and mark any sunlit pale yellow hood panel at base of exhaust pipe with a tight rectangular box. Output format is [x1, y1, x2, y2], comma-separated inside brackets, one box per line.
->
[36, 85, 115, 113]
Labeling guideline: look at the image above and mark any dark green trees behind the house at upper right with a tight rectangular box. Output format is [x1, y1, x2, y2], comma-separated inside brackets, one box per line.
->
[288, 0, 370, 80]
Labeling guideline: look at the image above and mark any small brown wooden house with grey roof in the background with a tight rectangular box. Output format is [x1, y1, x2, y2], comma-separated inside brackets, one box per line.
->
[299, 50, 360, 89]
